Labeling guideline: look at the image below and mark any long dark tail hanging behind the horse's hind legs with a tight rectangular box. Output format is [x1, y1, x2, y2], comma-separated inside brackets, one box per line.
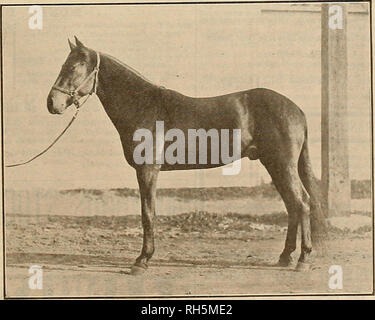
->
[298, 127, 327, 247]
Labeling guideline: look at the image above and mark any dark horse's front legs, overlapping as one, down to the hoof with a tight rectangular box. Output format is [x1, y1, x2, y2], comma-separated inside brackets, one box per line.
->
[131, 165, 160, 274]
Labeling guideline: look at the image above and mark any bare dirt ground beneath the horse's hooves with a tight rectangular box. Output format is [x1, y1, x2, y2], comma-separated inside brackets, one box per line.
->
[6, 212, 373, 297]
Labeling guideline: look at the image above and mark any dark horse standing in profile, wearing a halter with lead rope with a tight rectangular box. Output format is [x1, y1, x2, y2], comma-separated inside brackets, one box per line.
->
[47, 37, 326, 275]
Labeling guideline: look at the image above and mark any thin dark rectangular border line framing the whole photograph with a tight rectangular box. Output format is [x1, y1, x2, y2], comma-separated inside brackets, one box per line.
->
[0, 0, 375, 300]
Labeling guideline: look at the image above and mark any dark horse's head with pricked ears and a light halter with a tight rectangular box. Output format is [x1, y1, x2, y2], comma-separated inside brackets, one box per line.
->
[47, 37, 99, 114]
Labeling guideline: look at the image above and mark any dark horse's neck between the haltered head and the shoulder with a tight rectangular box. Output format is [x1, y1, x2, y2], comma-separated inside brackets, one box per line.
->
[97, 54, 158, 129]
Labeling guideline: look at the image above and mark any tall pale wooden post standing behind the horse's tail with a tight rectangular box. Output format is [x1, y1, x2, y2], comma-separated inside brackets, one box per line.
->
[321, 4, 351, 216]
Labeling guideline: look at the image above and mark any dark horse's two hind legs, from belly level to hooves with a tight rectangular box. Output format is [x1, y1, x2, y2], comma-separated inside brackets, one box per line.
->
[261, 158, 312, 266]
